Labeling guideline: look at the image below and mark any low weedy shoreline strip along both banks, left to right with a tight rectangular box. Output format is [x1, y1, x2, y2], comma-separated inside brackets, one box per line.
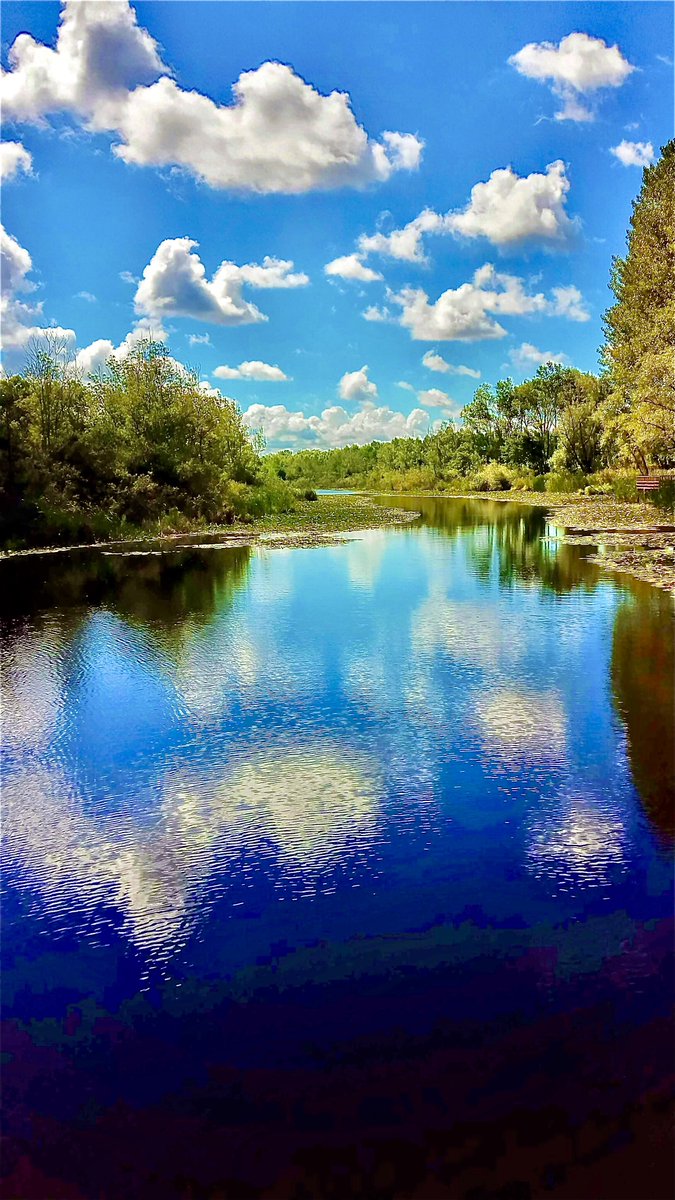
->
[0, 490, 675, 593]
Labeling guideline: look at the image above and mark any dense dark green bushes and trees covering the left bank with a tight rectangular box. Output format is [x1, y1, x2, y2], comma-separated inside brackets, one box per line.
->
[0, 335, 285, 545]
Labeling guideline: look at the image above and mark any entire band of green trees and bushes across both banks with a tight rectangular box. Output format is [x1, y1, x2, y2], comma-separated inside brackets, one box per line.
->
[0, 142, 675, 551]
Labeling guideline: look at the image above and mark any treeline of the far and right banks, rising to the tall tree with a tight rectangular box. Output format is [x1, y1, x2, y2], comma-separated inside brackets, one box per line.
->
[268, 142, 675, 499]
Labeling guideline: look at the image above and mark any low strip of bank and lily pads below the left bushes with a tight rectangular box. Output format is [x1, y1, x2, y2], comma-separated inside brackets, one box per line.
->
[0, 493, 419, 560]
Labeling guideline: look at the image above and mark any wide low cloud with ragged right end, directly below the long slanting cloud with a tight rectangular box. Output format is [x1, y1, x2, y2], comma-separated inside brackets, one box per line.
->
[389, 263, 589, 342]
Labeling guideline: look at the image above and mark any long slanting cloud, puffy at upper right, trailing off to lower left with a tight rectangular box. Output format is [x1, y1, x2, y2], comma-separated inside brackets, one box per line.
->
[353, 160, 571, 263]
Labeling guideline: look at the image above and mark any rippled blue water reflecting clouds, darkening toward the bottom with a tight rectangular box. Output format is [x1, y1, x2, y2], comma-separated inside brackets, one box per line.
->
[0, 499, 674, 1200]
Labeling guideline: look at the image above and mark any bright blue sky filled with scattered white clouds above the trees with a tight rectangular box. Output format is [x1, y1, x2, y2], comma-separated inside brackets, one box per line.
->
[0, 0, 674, 449]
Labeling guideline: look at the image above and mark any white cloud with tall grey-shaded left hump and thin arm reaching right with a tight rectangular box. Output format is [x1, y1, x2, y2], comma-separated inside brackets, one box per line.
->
[135, 238, 309, 325]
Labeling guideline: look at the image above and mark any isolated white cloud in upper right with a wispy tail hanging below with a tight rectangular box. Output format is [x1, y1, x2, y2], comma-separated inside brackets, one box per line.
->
[508, 34, 635, 121]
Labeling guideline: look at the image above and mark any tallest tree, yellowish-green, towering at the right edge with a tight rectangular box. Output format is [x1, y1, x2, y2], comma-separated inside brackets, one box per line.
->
[603, 140, 675, 470]
